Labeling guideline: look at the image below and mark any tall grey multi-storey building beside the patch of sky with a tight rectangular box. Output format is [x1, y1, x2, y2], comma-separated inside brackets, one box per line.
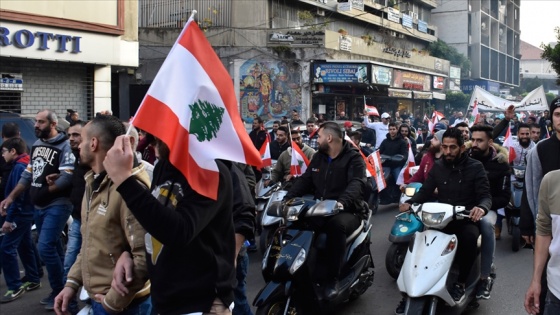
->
[432, 0, 521, 92]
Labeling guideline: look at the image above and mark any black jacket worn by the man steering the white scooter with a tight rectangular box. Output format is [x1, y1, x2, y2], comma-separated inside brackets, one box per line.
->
[407, 153, 492, 213]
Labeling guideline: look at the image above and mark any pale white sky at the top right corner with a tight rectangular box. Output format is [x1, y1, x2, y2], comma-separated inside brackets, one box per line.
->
[520, 0, 560, 47]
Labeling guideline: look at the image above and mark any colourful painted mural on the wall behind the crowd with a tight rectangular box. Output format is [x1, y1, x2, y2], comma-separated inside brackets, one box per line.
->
[239, 60, 301, 123]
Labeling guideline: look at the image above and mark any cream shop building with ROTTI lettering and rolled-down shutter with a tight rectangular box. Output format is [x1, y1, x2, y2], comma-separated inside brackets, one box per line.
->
[0, 0, 139, 119]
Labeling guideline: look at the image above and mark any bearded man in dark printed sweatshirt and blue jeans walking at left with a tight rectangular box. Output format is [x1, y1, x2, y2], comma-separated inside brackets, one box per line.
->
[0, 109, 76, 310]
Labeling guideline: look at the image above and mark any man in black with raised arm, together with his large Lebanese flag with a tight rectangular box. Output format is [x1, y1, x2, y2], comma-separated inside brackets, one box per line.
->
[104, 12, 266, 315]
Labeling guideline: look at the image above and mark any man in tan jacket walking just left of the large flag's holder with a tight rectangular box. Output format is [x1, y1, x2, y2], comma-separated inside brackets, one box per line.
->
[55, 115, 152, 315]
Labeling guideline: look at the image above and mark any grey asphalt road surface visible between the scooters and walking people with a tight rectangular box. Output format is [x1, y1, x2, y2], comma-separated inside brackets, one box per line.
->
[0, 205, 533, 315]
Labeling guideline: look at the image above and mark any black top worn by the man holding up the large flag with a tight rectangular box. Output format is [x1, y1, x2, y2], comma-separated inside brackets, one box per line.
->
[117, 160, 236, 314]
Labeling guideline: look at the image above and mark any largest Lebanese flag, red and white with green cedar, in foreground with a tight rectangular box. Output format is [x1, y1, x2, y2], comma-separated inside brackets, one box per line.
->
[131, 18, 262, 200]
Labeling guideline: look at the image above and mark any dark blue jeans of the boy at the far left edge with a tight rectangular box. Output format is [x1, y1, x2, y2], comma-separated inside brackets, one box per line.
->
[0, 217, 40, 291]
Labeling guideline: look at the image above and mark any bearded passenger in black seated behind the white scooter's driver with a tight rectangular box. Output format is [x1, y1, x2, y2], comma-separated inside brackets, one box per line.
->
[469, 125, 511, 300]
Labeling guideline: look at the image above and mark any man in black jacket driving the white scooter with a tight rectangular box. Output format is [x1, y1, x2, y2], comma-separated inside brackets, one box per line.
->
[399, 128, 492, 302]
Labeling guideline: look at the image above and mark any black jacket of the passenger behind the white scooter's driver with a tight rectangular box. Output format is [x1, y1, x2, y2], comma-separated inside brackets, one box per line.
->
[469, 147, 511, 210]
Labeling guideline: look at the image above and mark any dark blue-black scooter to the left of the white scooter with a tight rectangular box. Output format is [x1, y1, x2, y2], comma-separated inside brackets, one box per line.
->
[253, 198, 374, 315]
